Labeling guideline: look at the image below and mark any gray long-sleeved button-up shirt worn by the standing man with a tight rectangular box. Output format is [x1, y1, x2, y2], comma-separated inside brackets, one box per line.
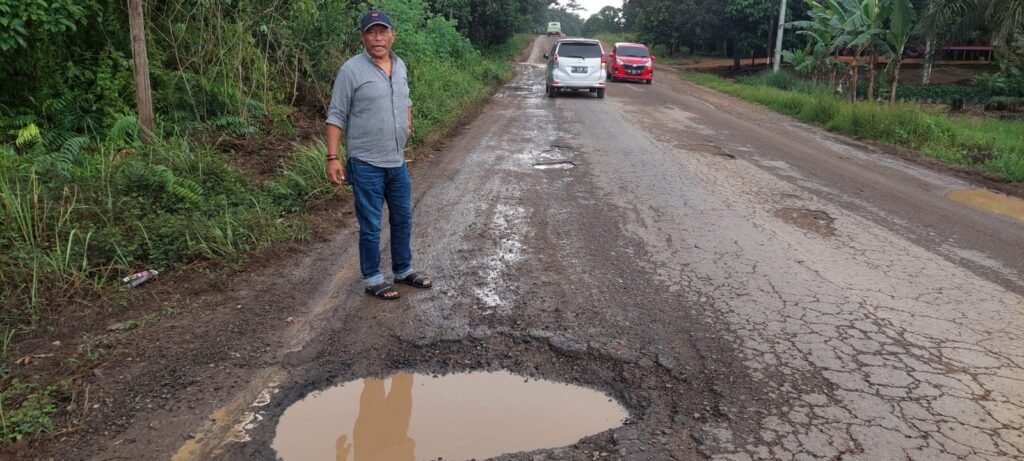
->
[327, 52, 413, 168]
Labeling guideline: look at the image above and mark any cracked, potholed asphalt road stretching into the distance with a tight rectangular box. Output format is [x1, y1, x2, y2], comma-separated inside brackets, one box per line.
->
[69, 39, 1024, 461]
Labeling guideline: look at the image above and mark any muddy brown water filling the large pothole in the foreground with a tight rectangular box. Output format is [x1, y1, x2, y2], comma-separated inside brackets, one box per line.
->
[273, 372, 628, 461]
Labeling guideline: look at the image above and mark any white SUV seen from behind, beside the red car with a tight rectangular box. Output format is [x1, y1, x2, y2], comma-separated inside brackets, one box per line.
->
[544, 39, 607, 98]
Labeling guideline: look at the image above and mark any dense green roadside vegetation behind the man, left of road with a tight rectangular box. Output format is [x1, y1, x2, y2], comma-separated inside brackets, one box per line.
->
[0, 0, 546, 447]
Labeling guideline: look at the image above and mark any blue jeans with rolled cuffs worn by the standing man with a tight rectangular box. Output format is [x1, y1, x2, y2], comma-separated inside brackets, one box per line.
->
[346, 158, 413, 286]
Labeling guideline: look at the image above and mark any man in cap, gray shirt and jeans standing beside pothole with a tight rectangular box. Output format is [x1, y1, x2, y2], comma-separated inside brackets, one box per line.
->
[327, 10, 431, 299]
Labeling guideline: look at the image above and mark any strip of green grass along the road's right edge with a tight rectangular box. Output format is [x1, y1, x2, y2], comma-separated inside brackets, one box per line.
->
[683, 73, 1024, 181]
